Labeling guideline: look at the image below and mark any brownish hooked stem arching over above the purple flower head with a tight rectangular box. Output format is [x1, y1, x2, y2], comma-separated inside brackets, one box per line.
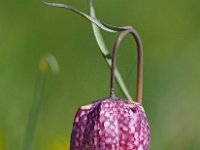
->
[110, 28, 143, 104]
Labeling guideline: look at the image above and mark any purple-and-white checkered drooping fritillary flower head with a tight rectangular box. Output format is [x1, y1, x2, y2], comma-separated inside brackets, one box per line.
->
[71, 98, 150, 150]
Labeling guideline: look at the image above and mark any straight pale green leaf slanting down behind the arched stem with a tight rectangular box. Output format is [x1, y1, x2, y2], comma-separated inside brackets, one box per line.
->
[90, 0, 132, 100]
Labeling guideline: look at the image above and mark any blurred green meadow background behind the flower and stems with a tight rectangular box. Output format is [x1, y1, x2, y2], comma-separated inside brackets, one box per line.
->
[0, 0, 200, 150]
